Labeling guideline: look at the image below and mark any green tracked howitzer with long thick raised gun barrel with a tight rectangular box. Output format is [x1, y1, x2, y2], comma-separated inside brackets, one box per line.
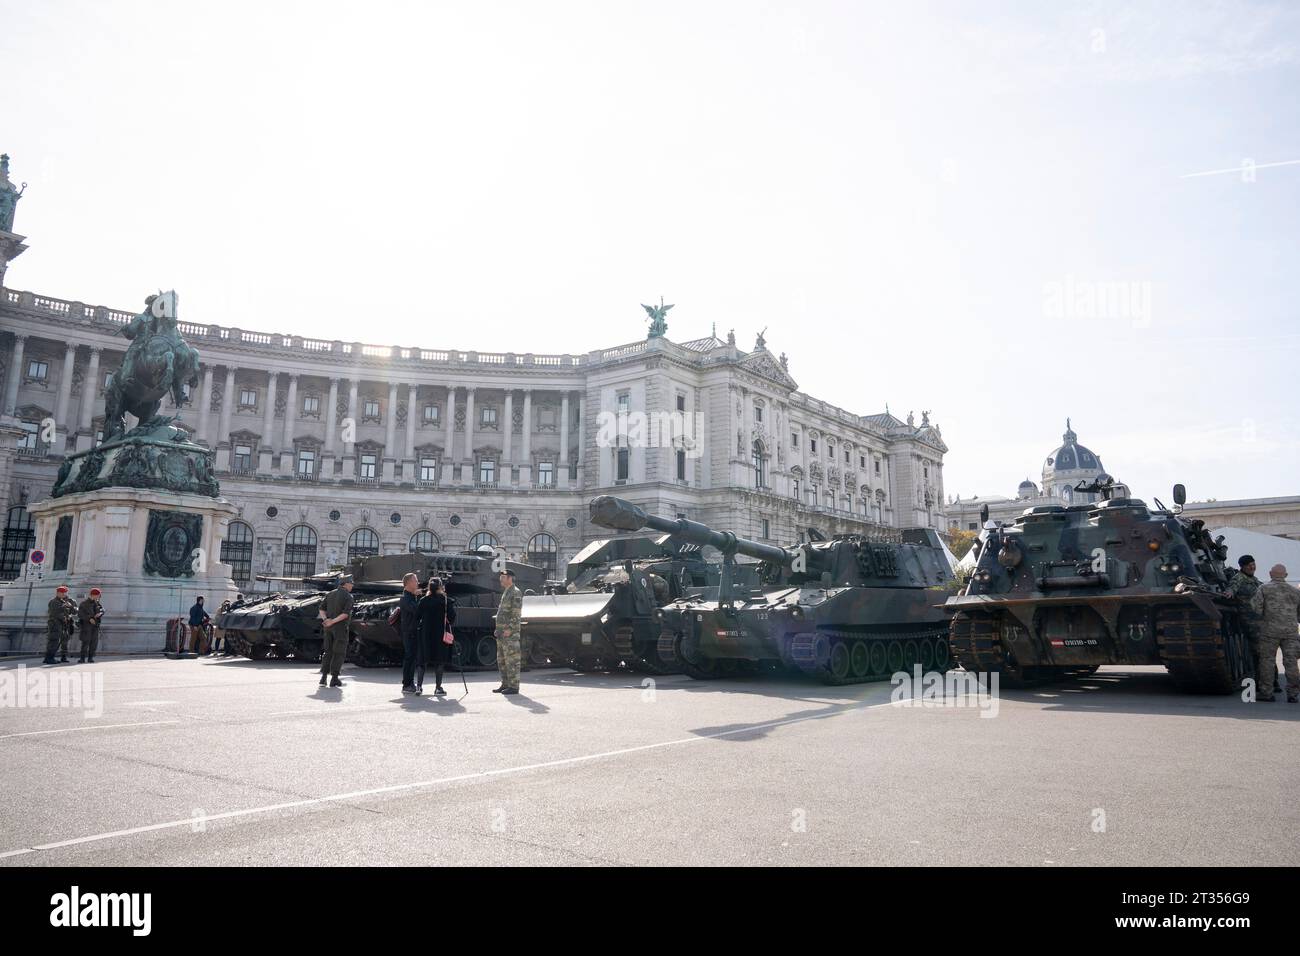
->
[590, 496, 952, 684]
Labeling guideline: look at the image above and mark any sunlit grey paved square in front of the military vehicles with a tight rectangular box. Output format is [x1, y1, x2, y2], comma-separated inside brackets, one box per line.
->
[0, 658, 1300, 866]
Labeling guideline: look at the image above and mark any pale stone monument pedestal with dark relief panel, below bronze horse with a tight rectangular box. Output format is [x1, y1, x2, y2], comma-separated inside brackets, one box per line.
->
[0, 488, 238, 654]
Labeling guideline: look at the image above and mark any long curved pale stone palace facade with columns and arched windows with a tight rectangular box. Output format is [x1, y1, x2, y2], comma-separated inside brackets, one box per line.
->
[0, 159, 948, 591]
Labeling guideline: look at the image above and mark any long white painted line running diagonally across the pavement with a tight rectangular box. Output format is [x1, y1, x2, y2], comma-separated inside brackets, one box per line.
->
[0, 701, 873, 860]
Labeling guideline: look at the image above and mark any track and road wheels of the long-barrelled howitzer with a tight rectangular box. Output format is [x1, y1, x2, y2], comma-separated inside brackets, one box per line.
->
[790, 627, 952, 685]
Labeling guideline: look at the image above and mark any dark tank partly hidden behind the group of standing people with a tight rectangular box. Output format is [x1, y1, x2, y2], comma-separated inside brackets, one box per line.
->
[352, 549, 546, 670]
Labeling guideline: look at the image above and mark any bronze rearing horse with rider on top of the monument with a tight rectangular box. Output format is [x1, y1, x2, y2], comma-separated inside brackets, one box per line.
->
[104, 291, 199, 441]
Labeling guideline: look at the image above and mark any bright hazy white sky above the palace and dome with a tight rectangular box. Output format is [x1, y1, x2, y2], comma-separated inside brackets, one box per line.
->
[0, 0, 1300, 501]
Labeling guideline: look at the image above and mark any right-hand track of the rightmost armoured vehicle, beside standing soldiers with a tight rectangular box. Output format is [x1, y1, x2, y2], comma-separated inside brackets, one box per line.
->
[1156, 604, 1249, 693]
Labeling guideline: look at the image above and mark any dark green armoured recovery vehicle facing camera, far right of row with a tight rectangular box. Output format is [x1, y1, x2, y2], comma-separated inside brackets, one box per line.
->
[946, 476, 1249, 693]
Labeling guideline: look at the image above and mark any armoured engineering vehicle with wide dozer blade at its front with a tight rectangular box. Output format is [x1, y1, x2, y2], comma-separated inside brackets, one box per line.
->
[521, 535, 719, 674]
